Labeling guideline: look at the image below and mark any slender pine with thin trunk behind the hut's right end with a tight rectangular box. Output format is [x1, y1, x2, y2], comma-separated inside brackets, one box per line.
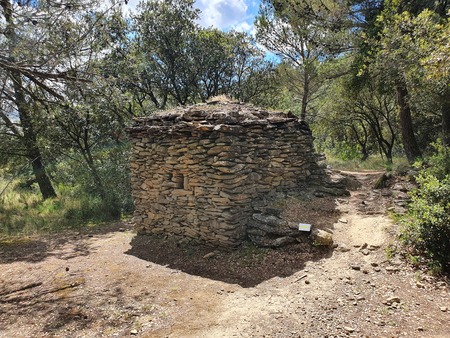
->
[255, 0, 336, 121]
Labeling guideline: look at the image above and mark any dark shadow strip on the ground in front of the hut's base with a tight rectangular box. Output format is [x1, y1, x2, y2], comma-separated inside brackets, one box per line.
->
[125, 235, 332, 287]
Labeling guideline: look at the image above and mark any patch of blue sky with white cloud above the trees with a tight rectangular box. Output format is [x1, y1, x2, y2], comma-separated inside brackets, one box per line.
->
[128, 0, 259, 33]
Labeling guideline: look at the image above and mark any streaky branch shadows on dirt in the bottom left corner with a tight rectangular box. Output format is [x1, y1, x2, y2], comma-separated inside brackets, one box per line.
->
[0, 269, 132, 337]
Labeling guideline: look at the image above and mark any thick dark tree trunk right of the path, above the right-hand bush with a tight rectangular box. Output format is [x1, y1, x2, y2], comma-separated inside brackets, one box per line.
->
[395, 84, 422, 163]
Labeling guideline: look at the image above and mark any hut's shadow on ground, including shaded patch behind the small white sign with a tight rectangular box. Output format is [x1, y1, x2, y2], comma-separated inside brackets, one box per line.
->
[126, 196, 339, 287]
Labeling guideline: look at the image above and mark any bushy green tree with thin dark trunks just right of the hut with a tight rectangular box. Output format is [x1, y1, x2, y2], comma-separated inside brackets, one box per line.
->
[314, 75, 399, 163]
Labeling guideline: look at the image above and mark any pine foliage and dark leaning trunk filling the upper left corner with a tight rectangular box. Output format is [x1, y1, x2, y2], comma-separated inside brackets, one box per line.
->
[0, 0, 127, 199]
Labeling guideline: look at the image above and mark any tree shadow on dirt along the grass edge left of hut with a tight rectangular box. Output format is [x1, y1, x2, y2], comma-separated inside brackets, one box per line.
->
[0, 222, 124, 264]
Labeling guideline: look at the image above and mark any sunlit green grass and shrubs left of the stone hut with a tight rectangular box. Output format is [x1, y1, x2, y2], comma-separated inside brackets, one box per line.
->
[0, 139, 134, 235]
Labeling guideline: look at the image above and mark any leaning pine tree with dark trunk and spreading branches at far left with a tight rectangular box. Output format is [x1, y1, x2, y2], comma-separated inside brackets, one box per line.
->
[0, 0, 123, 199]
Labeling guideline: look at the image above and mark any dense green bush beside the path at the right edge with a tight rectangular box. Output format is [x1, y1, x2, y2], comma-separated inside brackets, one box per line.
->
[401, 146, 450, 272]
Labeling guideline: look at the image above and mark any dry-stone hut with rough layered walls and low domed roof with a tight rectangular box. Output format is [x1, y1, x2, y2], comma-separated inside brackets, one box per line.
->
[128, 101, 325, 247]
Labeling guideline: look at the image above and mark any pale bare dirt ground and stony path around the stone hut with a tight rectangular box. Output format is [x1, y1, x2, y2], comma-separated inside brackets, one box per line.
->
[0, 172, 450, 338]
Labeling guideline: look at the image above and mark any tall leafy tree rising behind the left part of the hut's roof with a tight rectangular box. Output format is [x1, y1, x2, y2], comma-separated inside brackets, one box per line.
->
[133, 0, 198, 108]
